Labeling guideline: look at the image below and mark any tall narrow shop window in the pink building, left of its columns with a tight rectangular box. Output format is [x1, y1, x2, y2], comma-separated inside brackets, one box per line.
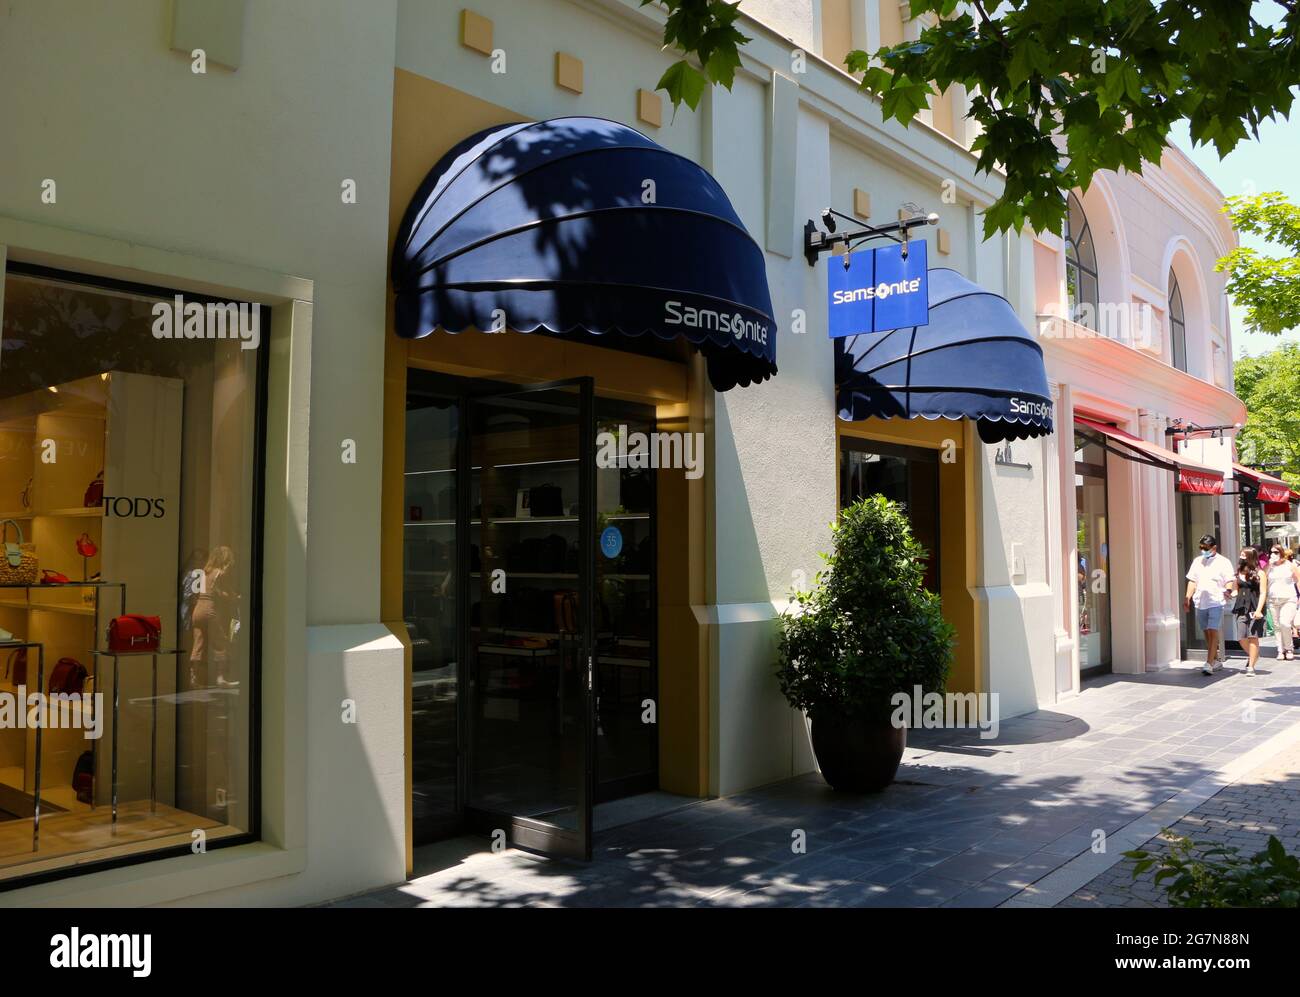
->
[1074, 429, 1110, 677]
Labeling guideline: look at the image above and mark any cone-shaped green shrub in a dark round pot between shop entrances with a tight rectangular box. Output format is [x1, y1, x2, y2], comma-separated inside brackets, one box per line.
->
[777, 495, 953, 793]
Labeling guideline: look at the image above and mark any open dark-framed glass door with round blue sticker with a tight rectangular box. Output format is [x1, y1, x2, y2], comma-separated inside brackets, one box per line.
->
[459, 378, 595, 858]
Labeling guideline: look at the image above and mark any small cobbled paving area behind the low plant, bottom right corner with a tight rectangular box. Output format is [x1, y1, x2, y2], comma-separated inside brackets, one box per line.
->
[1060, 744, 1300, 907]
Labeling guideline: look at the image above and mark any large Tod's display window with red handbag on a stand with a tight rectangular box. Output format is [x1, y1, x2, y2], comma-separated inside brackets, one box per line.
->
[0, 265, 261, 883]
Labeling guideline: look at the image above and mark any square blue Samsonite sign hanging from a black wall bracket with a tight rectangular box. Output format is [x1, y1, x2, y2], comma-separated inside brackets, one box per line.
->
[826, 242, 930, 339]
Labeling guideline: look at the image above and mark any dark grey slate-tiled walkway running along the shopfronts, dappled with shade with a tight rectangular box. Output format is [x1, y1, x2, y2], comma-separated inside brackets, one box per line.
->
[325, 660, 1300, 906]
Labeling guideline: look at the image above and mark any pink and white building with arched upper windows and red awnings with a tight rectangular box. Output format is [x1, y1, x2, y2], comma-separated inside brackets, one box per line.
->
[1034, 149, 1245, 697]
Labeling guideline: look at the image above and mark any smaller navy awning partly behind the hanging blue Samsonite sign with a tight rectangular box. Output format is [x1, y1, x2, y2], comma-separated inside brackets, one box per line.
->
[831, 269, 1052, 443]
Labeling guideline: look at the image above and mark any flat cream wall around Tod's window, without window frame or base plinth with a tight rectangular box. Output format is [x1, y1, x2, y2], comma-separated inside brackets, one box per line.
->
[0, 0, 395, 624]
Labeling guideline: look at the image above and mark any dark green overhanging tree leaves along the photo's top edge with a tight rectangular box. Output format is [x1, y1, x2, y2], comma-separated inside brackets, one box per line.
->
[642, 0, 1300, 235]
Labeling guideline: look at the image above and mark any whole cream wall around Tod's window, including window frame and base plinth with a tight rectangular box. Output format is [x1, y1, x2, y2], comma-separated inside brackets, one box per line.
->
[0, 0, 404, 905]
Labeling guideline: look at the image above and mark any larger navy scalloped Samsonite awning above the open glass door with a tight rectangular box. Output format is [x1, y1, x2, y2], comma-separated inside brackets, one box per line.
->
[393, 117, 776, 391]
